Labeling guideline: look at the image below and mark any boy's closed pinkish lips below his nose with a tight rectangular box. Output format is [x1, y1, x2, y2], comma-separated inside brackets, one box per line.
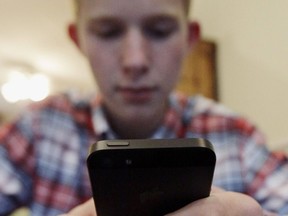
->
[116, 86, 158, 104]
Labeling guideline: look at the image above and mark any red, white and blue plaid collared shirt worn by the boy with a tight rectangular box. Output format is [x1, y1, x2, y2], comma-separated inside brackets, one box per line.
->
[0, 94, 288, 216]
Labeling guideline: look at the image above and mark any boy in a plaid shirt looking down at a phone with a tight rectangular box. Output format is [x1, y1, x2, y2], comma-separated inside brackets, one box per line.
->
[0, 0, 288, 216]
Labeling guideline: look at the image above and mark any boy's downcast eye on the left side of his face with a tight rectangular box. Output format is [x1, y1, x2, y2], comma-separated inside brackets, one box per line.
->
[88, 19, 125, 40]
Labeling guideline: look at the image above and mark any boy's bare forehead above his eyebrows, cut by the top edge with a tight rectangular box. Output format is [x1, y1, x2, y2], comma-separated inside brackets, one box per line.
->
[76, 0, 185, 19]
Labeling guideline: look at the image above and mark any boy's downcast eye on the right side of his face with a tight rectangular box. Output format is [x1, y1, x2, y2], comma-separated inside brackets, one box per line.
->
[143, 18, 178, 40]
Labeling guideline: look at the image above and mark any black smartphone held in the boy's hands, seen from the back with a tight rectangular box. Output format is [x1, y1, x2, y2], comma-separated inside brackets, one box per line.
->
[87, 138, 216, 216]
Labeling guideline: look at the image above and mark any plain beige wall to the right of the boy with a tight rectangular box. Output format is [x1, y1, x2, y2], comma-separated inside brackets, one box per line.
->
[192, 0, 288, 148]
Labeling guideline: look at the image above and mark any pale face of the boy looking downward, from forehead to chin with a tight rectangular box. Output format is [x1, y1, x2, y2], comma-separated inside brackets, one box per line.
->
[72, 0, 195, 121]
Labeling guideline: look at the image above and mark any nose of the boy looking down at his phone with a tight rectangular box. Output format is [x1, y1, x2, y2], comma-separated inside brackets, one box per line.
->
[121, 28, 149, 78]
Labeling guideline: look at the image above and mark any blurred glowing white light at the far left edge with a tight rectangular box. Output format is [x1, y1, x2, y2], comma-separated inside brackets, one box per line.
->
[1, 72, 50, 103]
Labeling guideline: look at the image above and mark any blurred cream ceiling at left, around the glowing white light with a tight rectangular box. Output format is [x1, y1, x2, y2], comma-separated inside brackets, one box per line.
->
[0, 0, 93, 120]
